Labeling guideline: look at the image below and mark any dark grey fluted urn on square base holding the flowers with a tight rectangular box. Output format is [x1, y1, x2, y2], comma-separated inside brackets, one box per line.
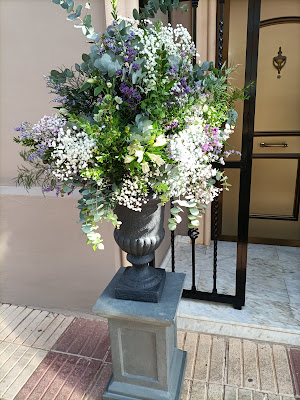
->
[114, 198, 166, 303]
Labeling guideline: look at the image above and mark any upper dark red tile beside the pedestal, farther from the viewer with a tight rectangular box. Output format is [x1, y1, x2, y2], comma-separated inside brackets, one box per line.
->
[52, 318, 110, 360]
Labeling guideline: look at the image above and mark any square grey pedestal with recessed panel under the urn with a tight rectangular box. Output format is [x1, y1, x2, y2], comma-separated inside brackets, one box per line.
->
[93, 268, 186, 400]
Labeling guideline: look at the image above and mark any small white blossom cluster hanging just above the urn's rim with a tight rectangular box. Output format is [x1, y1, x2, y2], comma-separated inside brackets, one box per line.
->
[116, 177, 147, 211]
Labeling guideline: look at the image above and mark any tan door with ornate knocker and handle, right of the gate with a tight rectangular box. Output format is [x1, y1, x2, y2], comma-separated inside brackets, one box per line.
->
[249, 23, 300, 243]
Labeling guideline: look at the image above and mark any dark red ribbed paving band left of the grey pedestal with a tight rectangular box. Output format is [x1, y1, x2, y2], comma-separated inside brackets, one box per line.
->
[14, 318, 112, 400]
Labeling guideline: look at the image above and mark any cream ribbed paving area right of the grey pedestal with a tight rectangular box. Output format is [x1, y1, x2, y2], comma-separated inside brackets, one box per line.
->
[178, 331, 294, 400]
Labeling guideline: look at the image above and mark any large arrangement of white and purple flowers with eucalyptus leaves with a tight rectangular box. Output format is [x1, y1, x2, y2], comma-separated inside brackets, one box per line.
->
[15, 0, 243, 249]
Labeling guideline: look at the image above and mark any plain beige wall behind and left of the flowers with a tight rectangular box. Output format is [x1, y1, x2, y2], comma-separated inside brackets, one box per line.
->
[0, 0, 169, 313]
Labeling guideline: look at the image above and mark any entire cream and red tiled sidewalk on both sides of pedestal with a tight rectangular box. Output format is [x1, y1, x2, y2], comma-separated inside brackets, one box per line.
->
[0, 304, 300, 400]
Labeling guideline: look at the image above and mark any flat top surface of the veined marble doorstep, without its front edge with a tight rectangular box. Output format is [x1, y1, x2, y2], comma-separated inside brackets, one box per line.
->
[165, 236, 300, 336]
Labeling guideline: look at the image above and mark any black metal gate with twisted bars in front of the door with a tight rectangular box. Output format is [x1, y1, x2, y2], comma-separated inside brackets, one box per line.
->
[169, 0, 261, 309]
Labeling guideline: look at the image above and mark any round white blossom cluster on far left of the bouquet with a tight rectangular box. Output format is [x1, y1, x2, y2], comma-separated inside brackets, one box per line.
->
[51, 126, 96, 181]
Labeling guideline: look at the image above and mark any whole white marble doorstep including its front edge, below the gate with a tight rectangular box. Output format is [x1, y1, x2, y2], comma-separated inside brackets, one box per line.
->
[161, 235, 300, 346]
